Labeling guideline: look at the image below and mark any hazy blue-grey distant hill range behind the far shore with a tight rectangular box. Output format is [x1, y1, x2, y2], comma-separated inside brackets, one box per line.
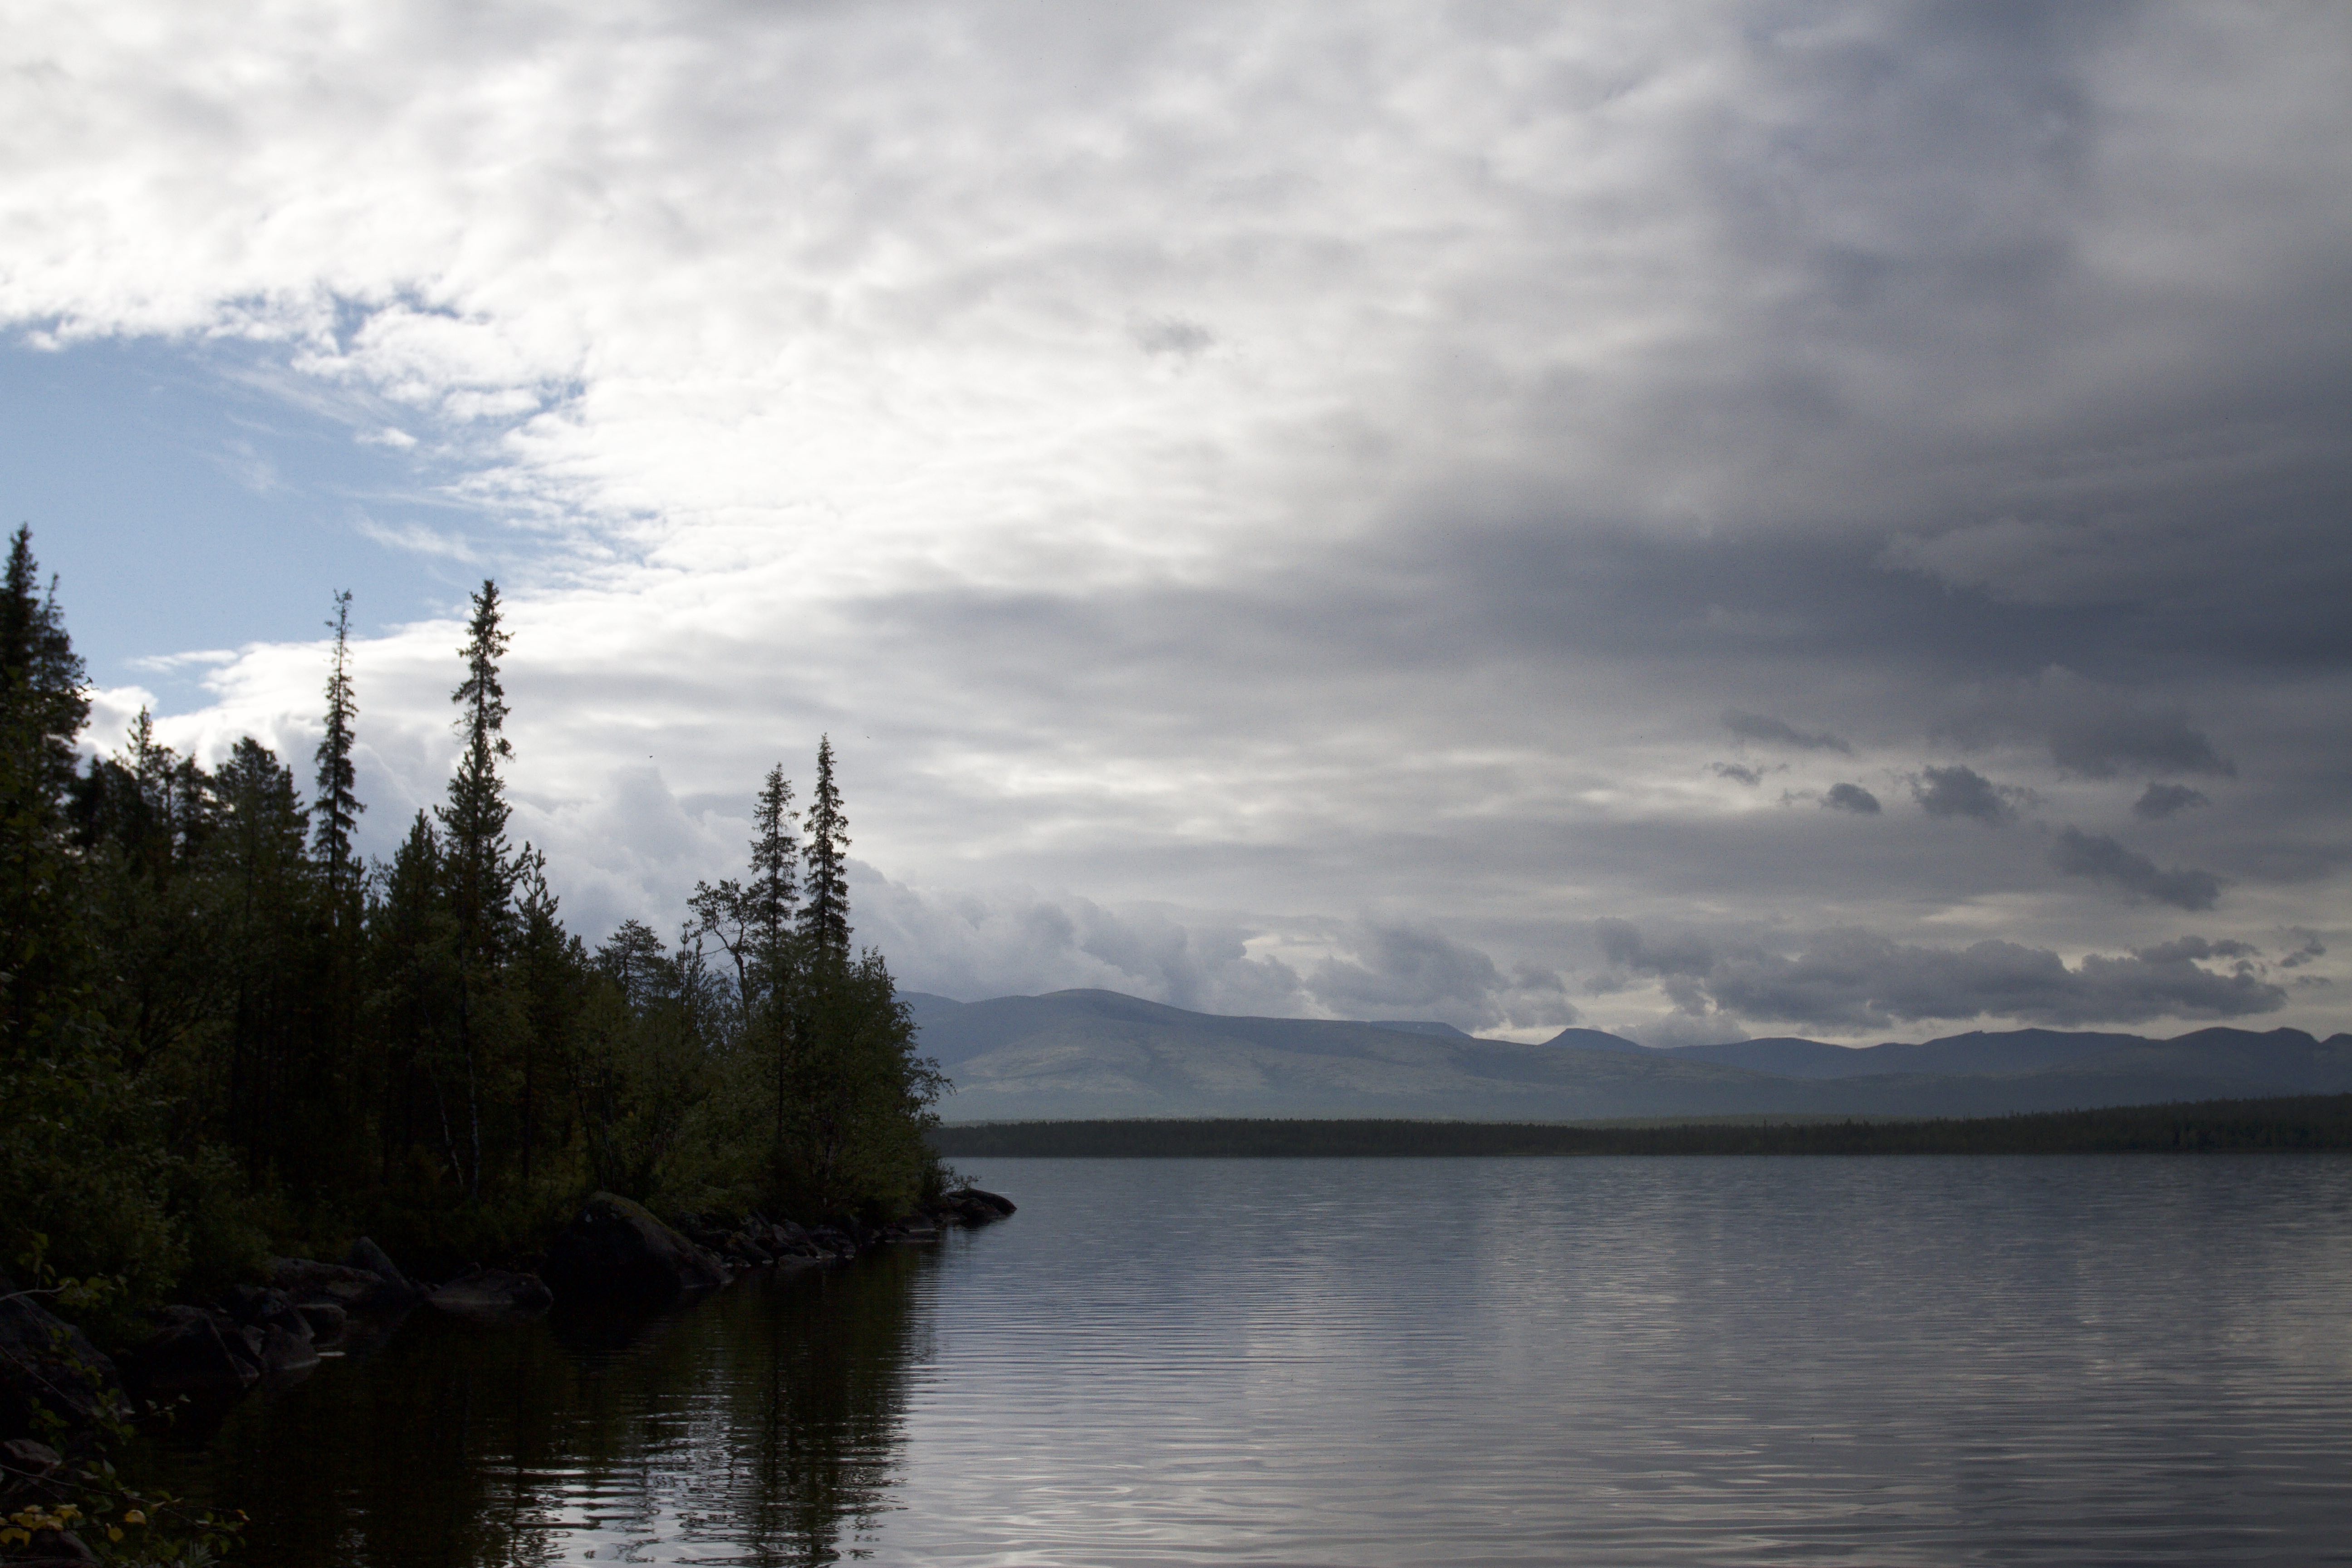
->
[901, 990, 2352, 1122]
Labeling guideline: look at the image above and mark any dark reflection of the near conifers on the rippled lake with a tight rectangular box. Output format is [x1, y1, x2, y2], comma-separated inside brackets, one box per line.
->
[144, 1248, 938, 1566]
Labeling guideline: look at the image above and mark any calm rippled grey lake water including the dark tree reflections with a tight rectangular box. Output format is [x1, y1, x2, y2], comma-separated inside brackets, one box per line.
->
[147, 1156, 2352, 1568]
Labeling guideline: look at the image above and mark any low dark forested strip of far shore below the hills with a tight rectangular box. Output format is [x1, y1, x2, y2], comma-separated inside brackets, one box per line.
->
[929, 1096, 2352, 1159]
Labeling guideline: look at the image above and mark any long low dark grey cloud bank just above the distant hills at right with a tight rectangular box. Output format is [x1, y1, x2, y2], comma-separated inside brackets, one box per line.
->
[1597, 921, 2286, 1032]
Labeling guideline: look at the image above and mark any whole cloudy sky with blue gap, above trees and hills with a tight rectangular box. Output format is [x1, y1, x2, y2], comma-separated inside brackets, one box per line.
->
[0, 0, 2352, 1044]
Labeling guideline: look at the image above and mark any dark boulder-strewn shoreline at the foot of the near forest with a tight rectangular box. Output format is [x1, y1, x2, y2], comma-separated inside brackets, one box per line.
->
[0, 1187, 1014, 1566]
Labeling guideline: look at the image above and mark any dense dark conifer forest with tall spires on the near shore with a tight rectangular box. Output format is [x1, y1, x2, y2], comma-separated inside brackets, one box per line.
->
[0, 529, 943, 1312]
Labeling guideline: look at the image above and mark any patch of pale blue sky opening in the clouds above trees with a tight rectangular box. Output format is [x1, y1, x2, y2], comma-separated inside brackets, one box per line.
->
[0, 338, 527, 712]
